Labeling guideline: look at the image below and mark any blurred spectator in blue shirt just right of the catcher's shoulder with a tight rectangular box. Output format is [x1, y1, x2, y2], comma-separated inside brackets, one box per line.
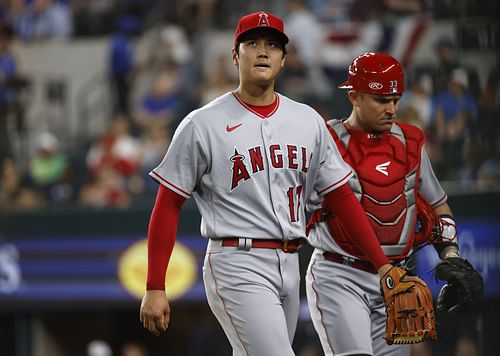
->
[433, 68, 478, 178]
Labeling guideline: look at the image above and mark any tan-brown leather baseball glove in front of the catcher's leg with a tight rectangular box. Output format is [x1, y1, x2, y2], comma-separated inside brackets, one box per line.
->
[380, 267, 437, 345]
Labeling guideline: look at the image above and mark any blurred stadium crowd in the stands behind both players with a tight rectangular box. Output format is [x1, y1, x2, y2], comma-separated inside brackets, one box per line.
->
[0, 0, 500, 211]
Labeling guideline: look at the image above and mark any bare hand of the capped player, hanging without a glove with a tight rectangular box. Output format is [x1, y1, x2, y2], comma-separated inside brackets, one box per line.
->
[140, 290, 170, 336]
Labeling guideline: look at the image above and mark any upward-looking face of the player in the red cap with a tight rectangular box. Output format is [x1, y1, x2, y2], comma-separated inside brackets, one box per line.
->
[233, 32, 285, 85]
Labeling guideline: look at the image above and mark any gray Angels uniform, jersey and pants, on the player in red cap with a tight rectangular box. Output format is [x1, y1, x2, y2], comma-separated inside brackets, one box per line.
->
[150, 93, 352, 356]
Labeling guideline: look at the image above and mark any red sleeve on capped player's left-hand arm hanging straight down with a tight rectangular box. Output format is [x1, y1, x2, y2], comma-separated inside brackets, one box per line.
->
[146, 184, 186, 290]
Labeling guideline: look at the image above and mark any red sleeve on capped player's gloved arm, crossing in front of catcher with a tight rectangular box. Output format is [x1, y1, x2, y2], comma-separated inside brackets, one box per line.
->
[324, 184, 389, 270]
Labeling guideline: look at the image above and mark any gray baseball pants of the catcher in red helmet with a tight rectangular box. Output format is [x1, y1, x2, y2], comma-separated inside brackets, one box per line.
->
[306, 249, 411, 356]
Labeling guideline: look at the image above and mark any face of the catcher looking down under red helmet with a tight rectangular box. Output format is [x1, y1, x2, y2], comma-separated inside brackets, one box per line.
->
[349, 90, 401, 132]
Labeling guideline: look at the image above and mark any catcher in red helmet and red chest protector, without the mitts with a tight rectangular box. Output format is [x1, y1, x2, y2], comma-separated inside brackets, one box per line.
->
[306, 52, 482, 356]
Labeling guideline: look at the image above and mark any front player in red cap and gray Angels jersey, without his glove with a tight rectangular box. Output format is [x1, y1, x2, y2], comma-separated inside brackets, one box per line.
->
[140, 11, 396, 356]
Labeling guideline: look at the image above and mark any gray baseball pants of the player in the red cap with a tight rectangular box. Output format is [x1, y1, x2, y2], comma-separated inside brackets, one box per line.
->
[203, 240, 300, 356]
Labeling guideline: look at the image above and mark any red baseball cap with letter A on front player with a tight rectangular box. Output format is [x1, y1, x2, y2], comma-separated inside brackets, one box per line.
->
[234, 11, 288, 47]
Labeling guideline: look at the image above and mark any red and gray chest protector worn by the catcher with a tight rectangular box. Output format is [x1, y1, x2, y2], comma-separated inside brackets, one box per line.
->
[327, 120, 424, 259]
